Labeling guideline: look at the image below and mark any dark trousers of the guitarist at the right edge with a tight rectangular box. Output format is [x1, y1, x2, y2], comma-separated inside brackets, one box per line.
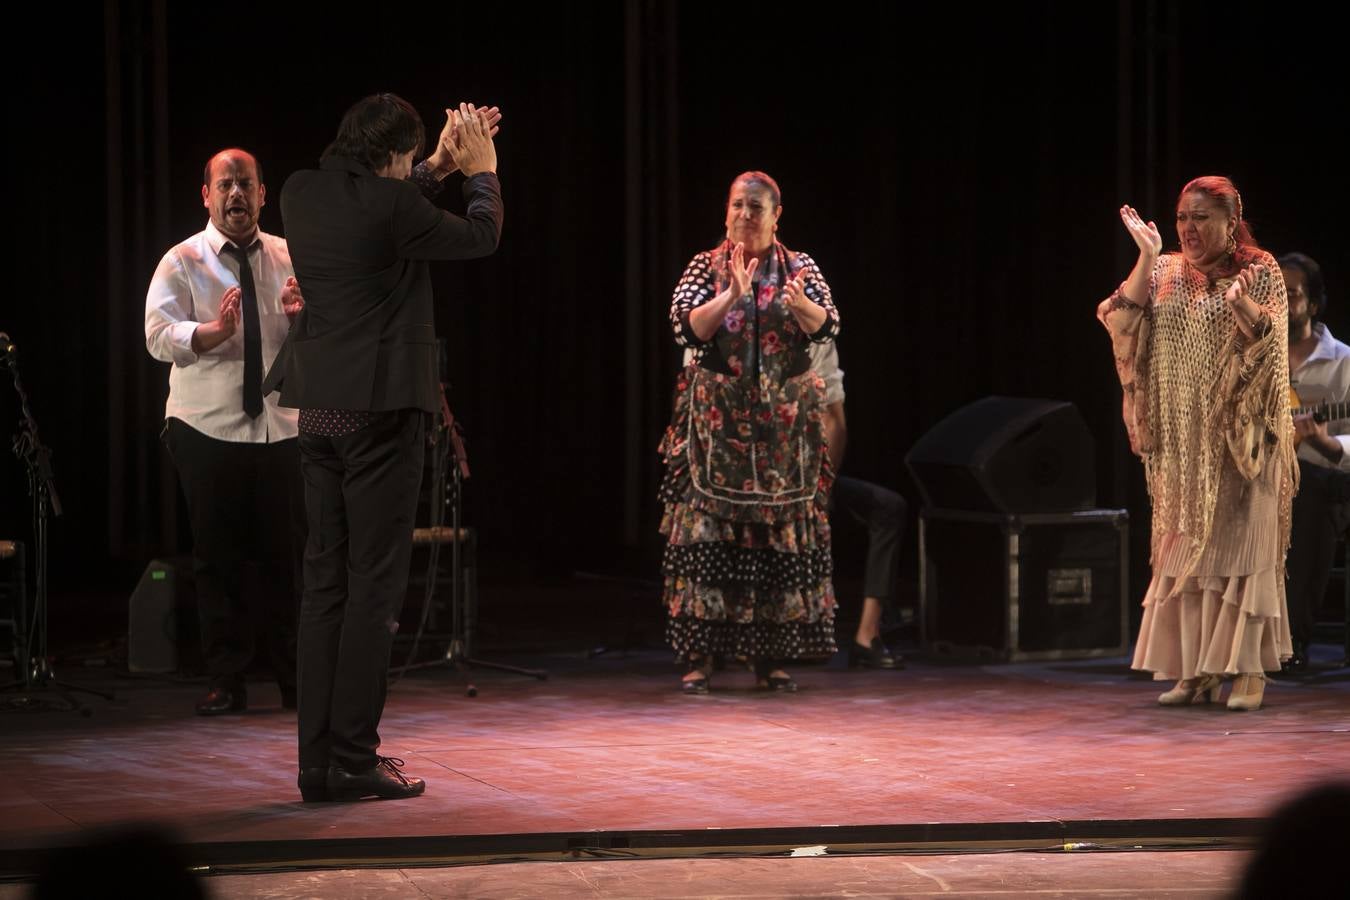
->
[1285, 459, 1350, 649]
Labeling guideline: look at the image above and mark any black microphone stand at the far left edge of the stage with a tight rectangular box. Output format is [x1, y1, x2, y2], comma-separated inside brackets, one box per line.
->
[0, 332, 112, 715]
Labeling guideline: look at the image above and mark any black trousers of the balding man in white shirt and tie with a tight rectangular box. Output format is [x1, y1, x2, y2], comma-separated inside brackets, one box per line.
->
[163, 418, 305, 691]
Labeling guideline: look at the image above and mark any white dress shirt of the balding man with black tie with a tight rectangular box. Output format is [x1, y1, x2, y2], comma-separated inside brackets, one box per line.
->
[146, 221, 298, 444]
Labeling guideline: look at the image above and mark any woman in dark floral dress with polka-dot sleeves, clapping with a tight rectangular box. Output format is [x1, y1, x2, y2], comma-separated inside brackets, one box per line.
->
[660, 171, 838, 694]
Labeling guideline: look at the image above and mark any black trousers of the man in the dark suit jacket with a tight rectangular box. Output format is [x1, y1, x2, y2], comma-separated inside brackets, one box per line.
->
[298, 409, 427, 772]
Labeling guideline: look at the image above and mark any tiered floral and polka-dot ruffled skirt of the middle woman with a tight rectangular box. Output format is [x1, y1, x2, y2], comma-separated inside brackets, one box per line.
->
[660, 366, 836, 660]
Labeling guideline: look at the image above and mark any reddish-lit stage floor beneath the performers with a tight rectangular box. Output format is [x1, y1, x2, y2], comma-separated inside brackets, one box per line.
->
[0, 639, 1350, 896]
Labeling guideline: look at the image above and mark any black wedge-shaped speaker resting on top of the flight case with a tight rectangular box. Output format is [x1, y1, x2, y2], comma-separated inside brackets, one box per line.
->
[905, 397, 1096, 513]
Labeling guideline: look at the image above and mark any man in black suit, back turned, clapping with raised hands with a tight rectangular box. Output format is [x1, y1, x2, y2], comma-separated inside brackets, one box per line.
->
[263, 93, 502, 800]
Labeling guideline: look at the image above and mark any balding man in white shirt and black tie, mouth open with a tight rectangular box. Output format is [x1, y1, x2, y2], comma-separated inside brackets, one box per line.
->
[146, 148, 304, 715]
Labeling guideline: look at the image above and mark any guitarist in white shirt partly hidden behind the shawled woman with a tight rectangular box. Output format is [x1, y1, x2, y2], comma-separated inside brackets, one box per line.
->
[1280, 252, 1350, 675]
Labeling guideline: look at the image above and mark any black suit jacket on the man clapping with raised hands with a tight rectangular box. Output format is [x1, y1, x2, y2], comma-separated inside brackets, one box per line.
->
[263, 157, 502, 412]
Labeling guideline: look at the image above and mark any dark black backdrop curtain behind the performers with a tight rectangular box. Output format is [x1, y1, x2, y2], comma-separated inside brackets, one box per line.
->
[0, 0, 1347, 634]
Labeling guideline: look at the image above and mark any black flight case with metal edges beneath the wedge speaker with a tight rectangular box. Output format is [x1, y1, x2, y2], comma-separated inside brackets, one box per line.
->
[919, 510, 1130, 661]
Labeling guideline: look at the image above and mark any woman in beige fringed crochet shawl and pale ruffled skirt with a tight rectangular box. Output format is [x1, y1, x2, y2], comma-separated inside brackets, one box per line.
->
[1098, 175, 1299, 710]
